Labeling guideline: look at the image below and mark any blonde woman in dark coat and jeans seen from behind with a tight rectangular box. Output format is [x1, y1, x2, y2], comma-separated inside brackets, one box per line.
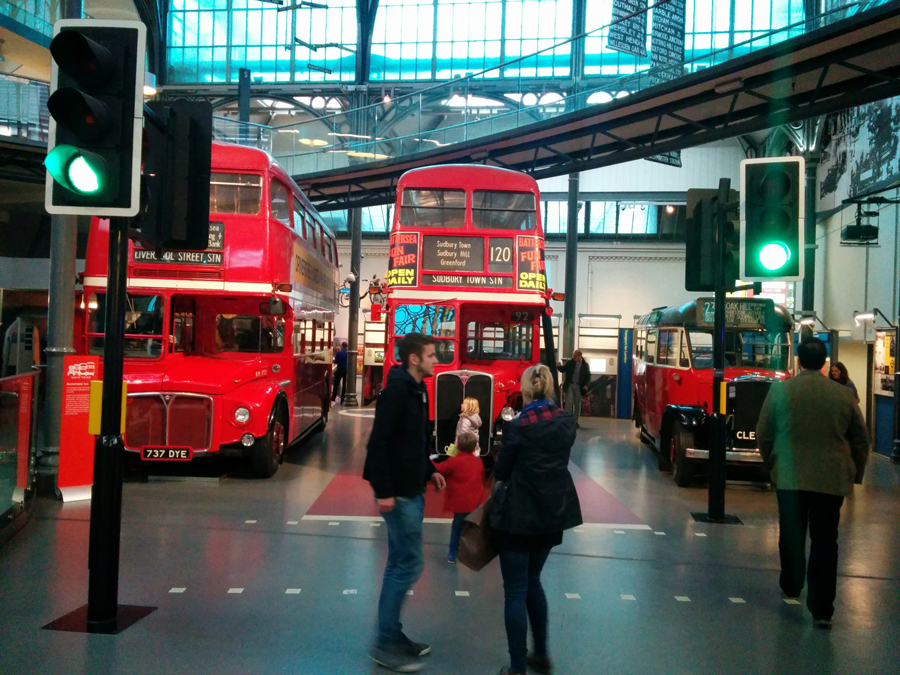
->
[491, 365, 582, 675]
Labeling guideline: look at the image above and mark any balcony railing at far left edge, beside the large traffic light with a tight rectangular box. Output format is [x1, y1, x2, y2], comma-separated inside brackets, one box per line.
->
[0, 74, 50, 145]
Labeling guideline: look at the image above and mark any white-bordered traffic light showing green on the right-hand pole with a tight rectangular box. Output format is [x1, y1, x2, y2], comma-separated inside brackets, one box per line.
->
[740, 157, 805, 281]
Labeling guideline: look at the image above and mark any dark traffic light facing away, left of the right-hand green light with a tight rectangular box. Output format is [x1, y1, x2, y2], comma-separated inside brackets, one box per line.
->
[684, 189, 740, 292]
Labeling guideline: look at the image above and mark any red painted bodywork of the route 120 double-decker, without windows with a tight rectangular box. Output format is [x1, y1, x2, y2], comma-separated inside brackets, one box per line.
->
[384, 165, 549, 436]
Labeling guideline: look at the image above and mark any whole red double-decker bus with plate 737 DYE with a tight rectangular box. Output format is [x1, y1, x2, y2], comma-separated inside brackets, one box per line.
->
[76, 143, 338, 477]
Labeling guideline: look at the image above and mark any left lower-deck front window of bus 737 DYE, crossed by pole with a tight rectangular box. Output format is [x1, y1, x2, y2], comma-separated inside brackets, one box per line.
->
[87, 293, 165, 359]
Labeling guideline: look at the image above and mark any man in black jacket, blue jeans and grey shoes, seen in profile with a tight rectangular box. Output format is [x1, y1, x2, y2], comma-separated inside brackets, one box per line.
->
[363, 333, 446, 673]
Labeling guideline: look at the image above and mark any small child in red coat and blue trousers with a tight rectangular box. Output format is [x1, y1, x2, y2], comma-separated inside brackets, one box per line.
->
[437, 432, 484, 565]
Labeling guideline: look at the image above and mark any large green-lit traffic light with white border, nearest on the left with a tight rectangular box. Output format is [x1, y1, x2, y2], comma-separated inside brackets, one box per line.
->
[44, 19, 147, 216]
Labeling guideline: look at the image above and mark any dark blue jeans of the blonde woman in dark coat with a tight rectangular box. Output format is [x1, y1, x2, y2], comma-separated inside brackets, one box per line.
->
[500, 548, 550, 673]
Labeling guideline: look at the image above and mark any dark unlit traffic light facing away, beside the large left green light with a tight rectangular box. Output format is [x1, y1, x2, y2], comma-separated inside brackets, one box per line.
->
[140, 99, 212, 251]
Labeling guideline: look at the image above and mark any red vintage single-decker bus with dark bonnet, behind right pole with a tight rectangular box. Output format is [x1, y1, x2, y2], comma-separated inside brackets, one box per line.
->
[633, 298, 793, 487]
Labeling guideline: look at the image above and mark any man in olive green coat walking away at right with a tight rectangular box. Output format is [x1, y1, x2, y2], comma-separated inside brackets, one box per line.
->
[756, 338, 869, 628]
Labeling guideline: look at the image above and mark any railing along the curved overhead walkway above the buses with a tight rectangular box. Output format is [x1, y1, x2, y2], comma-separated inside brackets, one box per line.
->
[272, 0, 888, 175]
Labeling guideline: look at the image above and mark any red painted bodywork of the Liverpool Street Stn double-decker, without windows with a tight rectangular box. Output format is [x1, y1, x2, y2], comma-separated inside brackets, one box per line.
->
[76, 143, 338, 457]
